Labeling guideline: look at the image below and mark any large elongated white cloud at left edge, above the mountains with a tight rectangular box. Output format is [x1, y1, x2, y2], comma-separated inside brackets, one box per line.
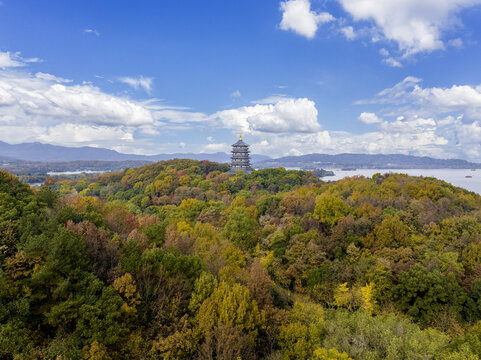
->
[0, 64, 163, 148]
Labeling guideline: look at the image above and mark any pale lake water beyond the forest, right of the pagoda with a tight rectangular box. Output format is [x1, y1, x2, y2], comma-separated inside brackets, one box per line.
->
[322, 169, 481, 194]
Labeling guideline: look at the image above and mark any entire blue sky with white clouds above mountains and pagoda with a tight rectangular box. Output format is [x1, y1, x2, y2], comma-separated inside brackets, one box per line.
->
[0, 0, 481, 162]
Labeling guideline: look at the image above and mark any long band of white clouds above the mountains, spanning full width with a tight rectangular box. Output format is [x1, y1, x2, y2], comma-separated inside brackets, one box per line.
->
[0, 53, 481, 161]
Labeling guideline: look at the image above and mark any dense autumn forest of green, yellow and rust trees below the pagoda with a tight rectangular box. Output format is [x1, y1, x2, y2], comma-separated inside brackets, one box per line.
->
[0, 159, 481, 360]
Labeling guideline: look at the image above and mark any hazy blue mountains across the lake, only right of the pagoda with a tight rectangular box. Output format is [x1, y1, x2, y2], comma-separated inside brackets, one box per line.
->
[256, 154, 481, 169]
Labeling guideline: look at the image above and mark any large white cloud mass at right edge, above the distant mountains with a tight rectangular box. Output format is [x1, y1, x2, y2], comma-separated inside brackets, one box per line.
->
[350, 76, 481, 162]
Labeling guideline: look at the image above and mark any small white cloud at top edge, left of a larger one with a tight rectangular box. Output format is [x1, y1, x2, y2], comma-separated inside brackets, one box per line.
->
[280, 0, 335, 39]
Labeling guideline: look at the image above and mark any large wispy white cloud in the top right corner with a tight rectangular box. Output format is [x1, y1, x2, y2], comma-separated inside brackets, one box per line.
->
[338, 0, 481, 56]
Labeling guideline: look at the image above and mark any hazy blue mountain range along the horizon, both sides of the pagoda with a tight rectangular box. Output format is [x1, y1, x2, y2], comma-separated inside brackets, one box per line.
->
[0, 141, 481, 170]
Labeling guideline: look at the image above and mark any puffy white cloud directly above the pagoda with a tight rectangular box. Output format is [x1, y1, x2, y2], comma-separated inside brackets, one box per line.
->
[213, 98, 321, 133]
